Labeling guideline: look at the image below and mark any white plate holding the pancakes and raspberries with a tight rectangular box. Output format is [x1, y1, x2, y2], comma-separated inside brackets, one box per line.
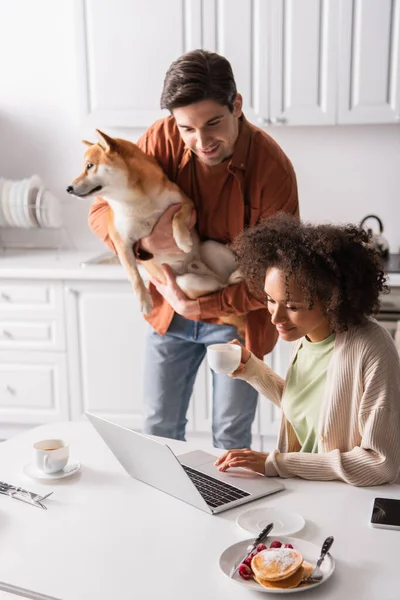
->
[219, 536, 335, 594]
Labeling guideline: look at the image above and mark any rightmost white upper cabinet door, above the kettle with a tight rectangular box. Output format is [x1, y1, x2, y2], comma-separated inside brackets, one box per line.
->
[338, 0, 400, 123]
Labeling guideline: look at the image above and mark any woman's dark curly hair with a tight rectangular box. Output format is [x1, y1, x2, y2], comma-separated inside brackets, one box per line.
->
[231, 213, 389, 332]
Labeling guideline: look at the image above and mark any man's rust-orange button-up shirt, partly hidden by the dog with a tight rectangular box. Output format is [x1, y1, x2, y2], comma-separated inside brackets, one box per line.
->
[89, 117, 299, 357]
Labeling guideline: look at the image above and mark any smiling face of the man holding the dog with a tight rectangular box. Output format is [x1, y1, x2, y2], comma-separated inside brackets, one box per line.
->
[172, 94, 242, 166]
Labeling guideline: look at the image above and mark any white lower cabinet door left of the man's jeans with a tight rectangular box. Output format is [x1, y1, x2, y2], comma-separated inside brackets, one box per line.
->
[66, 281, 147, 429]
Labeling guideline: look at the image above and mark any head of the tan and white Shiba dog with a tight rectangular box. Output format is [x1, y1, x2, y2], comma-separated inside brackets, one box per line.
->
[67, 129, 134, 198]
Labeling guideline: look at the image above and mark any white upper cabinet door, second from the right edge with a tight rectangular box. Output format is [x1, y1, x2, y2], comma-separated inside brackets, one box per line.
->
[270, 0, 338, 125]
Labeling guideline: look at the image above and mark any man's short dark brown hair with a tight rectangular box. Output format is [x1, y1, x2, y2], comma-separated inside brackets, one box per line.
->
[161, 50, 237, 112]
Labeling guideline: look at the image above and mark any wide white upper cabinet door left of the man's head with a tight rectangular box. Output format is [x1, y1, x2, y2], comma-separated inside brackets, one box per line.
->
[76, 0, 201, 127]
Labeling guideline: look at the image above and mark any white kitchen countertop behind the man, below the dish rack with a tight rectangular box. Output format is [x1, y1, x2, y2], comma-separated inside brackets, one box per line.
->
[0, 249, 400, 287]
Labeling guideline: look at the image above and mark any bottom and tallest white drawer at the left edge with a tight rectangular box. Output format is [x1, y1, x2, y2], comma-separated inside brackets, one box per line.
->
[0, 351, 69, 423]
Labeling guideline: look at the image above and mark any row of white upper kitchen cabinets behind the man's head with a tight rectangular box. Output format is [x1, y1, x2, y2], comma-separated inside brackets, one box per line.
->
[75, 0, 400, 128]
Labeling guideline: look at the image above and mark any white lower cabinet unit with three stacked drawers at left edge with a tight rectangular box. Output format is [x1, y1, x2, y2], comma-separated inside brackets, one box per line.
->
[0, 279, 70, 428]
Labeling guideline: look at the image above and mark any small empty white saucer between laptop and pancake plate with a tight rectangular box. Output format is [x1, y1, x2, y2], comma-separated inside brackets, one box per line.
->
[236, 506, 305, 536]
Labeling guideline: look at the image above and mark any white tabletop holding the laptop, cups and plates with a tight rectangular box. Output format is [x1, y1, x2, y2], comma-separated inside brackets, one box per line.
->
[0, 422, 400, 600]
